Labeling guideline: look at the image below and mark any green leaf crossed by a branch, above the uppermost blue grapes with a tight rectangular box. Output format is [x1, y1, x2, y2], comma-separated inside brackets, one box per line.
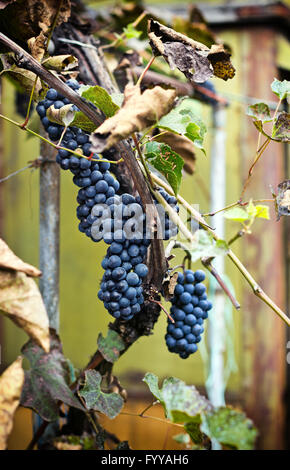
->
[72, 85, 119, 133]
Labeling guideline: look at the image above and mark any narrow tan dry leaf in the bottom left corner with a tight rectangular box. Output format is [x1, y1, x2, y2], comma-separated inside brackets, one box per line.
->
[0, 356, 24, 450]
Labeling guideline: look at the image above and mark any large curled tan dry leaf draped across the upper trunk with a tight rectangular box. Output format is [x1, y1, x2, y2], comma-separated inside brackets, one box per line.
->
[92, 85, 176, 152]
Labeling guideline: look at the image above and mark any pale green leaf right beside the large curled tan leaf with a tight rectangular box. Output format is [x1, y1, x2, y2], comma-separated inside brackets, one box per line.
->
[158, 99, 206, 153]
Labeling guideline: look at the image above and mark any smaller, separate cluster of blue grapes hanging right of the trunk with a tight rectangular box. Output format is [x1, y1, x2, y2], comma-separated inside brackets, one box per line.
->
[165, 269, 212, 359]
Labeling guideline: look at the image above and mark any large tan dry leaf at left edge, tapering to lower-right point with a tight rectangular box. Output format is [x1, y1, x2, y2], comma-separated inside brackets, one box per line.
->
[0, 270, 49, 352]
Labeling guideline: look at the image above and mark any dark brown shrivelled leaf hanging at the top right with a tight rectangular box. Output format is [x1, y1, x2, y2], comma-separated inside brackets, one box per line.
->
[148, 20, 235, 83]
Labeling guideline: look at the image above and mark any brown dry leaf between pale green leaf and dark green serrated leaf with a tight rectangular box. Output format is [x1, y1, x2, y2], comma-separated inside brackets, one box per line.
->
[156, 132, 196, 175]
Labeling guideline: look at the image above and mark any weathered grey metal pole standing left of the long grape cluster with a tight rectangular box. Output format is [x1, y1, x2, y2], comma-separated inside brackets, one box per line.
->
[39, 142, 60, 331]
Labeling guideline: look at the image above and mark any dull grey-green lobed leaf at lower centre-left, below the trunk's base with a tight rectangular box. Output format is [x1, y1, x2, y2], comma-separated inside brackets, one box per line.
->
[79, 370, 124, 419]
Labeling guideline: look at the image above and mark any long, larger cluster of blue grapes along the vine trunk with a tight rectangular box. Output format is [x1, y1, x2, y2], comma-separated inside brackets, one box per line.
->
[36, 79, 178, 320]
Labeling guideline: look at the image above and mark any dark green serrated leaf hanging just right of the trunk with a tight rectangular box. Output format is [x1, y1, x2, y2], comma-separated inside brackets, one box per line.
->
[145, 142, 184, 196]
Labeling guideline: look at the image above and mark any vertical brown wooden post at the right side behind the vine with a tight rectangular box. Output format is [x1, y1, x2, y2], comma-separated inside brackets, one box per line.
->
[238, 25, 286, 449]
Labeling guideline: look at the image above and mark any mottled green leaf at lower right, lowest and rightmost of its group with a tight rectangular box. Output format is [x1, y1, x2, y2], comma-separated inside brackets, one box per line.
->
[201, 407, 257, 450]
